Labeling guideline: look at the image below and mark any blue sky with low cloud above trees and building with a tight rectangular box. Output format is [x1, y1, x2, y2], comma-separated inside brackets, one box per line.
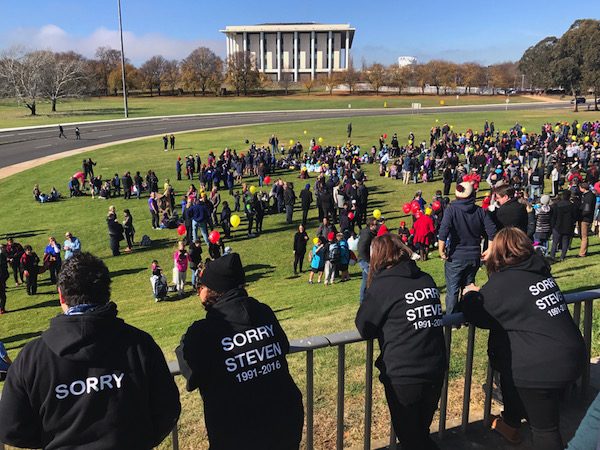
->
[0, 0, 598, 66]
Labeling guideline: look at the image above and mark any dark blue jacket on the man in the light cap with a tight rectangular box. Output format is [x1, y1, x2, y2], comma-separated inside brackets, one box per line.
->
[439, 197, 496, 261]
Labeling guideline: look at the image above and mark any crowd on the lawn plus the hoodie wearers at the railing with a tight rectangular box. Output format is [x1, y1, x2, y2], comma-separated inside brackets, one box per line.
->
[0, 117, 600, 450]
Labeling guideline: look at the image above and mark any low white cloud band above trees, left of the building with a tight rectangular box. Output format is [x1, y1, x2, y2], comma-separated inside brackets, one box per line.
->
[0, 24, 225, 64]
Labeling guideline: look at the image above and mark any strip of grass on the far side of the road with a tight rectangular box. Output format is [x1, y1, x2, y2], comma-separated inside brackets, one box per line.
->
[0, 93, 535, 128]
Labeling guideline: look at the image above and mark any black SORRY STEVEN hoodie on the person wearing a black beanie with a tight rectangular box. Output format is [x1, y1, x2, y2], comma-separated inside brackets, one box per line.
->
[175, 288, 304, 450]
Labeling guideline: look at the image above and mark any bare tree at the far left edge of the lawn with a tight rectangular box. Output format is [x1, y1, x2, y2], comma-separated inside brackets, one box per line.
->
[0, 50, 48, 116]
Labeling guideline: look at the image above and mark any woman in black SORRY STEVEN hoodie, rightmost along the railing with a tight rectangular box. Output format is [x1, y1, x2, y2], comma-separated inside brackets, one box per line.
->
[461, 227, 586, 450]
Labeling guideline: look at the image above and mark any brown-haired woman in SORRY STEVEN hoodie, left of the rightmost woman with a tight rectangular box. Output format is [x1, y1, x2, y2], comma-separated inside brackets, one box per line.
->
[356, 234, 447, 450]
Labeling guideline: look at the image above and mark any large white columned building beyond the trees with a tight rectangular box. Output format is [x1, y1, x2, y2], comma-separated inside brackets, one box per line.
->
[221, 23, 355, 81]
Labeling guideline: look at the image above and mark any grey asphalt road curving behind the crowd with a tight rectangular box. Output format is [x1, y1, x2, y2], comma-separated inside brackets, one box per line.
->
[0, 102, 569, 168]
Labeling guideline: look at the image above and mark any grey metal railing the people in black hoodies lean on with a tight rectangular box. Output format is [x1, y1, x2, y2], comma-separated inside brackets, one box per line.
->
[165, 289, 600, 450]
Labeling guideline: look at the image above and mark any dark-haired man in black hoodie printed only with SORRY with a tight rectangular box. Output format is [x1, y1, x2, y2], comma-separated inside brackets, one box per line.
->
[0, 252, 181, 449]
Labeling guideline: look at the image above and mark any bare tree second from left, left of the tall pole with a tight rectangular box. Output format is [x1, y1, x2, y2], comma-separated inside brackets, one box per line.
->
[43, 51, 88, 112]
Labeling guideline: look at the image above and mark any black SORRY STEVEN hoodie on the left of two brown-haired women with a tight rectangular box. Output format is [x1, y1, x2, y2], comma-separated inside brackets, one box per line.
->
[355, 261, 446, 385]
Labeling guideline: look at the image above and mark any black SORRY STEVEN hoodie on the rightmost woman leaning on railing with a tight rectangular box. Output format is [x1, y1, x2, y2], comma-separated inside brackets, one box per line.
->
[460, 254, 586, 389]
